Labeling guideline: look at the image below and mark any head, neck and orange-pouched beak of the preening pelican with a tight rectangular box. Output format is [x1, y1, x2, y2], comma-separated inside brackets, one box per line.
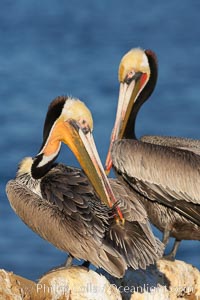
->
[31, 97, 122, 218]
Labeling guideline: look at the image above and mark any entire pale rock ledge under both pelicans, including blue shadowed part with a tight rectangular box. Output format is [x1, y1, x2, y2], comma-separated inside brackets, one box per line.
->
[0, 260, 200, 300]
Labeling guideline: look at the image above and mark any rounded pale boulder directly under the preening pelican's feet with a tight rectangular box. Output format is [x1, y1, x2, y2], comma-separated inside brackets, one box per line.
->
[37, 267, 122, 300]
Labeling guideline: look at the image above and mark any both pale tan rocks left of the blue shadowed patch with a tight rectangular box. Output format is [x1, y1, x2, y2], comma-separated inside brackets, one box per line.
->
[0, 266, 122, 300]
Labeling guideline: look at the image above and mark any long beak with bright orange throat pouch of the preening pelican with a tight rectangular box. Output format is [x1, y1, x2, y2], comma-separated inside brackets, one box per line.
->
[41, 119, 123, 219]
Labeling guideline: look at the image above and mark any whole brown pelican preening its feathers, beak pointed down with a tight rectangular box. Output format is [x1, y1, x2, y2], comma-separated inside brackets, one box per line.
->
[6, 97, 163, 277]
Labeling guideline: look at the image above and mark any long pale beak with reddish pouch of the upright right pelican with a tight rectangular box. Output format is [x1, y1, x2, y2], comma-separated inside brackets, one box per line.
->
[105, 73, 146, 175]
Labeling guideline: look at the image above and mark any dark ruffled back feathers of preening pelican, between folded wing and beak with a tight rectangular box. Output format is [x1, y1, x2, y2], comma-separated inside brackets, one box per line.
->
[41, 164, 112, 241]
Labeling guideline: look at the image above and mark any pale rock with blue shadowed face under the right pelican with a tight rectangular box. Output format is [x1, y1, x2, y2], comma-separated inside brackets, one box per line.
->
[103, 259, 200, 300]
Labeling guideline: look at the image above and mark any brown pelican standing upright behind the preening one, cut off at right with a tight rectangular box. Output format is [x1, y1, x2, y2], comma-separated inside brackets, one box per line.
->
[106, 49, 200, 257]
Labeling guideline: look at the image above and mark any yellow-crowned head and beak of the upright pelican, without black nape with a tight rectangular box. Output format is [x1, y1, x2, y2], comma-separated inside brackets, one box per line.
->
[105, 48, 150, 174]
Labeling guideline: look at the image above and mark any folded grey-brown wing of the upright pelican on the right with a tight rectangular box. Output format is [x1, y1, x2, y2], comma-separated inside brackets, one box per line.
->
[112, 140, 200, 225]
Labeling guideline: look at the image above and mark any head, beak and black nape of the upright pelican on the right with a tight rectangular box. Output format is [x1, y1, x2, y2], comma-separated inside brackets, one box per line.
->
[106, 48, 157, 173]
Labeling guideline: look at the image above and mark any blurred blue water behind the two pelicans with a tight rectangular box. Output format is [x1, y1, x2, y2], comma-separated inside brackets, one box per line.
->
[0, 0, 200, 279]
